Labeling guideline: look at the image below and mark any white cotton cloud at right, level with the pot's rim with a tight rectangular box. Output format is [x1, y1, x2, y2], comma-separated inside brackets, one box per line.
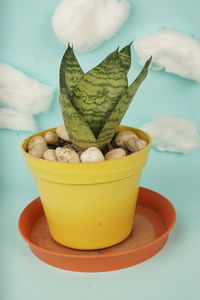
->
[140, 116, 200, 153]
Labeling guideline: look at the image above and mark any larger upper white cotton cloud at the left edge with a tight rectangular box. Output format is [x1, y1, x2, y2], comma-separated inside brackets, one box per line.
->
[0, 63, 54, 114]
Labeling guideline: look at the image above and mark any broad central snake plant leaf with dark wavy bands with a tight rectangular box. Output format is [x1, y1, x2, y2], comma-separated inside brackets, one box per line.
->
[72, 51, 128, 137]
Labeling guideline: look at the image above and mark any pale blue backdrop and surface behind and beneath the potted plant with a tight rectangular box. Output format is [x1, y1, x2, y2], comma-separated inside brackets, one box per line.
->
[0, 0, 200, 300]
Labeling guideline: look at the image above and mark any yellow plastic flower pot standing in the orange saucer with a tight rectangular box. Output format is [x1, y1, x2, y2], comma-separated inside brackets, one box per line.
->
[22, 126, 151, 250]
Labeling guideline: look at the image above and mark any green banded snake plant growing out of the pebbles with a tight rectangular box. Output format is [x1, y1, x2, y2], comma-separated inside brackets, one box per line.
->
[60, 45, 151, 151]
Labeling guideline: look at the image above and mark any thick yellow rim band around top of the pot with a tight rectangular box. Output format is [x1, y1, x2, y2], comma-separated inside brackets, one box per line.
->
[21, 126, 151, 184]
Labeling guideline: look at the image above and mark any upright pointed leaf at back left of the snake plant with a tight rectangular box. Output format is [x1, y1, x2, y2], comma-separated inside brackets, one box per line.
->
[60, 46, 84, 95]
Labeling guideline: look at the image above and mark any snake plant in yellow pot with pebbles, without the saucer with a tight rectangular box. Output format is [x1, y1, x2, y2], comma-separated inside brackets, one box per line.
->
[22, 45, 151, 250]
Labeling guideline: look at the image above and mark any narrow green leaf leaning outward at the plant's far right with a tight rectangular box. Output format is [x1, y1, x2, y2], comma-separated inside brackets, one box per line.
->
[97, 58, 151, 148]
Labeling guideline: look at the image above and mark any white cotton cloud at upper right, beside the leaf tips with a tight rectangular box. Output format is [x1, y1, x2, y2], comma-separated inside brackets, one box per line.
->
[134, 28, 200, 82]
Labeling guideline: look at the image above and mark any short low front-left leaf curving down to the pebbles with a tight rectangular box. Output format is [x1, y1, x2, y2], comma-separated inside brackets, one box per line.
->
[60, 89, 97, 151]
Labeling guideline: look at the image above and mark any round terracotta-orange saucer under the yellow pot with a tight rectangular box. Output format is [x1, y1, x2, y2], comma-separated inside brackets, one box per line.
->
[19, 187, 176, 272]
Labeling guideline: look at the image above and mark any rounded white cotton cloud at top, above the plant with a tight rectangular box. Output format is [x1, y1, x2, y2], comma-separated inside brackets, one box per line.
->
[52, 0, 130, 51]
